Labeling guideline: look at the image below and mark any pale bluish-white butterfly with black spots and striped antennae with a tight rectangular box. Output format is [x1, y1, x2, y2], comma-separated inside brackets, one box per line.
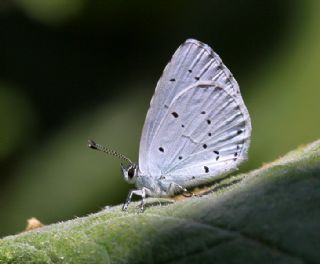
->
[89, 39, 251, 210]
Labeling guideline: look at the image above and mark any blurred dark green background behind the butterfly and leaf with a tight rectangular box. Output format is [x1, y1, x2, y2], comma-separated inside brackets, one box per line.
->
[0, 0, 320, 235]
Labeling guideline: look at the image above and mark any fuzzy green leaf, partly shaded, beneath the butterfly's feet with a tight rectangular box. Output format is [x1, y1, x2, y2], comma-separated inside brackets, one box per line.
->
[0, 141, 320, 263]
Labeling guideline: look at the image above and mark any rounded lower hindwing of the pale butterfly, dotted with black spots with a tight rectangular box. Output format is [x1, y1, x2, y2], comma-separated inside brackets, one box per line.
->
[142, 81, 251, 186]
